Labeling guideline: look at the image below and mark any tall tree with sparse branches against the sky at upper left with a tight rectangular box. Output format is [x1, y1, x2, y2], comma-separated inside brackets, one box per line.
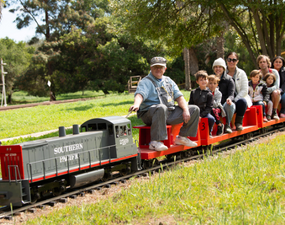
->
[5, 0, 108, 98]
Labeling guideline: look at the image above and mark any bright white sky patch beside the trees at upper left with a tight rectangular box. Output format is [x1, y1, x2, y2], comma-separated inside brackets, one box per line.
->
[0, 8, 36, 42]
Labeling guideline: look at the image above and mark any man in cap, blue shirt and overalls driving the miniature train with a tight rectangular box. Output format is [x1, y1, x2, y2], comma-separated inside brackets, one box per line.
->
[129, 57, 199, 151]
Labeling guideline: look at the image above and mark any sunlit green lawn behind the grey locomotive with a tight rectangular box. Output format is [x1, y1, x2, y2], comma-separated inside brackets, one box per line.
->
[0, 91, 189, 141]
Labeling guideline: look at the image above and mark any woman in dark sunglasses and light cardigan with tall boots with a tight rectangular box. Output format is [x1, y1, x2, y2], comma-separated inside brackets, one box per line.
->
[226, 52, 252, 130]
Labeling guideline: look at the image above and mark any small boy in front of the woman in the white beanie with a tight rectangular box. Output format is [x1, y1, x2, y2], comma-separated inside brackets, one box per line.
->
[208, 75, 226, 135]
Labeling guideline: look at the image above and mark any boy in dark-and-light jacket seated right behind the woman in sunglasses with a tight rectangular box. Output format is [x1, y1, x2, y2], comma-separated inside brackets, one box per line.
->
[248, 70, 269, 122]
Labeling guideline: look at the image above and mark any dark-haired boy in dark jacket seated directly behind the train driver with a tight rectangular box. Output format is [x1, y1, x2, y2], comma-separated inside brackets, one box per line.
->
[188, 70, 215, 135]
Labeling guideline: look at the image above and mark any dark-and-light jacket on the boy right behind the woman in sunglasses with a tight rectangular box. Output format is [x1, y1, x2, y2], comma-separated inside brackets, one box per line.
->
[248, 81, 269, 102]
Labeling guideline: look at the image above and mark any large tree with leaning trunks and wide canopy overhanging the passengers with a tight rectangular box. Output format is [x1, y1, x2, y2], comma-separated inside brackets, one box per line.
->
[113, 0, 285, 65]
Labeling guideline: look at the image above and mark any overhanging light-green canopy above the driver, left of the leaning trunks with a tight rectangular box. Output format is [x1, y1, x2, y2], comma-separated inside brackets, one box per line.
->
[111, 0, 221, 55]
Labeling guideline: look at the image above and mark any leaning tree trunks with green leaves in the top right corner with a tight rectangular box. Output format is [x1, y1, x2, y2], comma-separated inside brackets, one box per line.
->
[217, 0, 285, 66]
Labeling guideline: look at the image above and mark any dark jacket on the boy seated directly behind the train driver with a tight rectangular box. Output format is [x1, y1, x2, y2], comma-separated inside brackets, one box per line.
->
[188, 87, 214, 117]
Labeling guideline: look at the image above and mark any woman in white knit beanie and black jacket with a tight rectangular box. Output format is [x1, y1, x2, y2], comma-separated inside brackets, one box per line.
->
[213, 58, 236, 133]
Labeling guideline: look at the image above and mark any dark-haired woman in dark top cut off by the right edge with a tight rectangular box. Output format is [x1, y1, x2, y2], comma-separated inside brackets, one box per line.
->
[271, 56, 285, 118]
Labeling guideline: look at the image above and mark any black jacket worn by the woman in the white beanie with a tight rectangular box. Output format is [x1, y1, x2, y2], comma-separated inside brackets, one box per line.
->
[219, 72, 235, 105]
